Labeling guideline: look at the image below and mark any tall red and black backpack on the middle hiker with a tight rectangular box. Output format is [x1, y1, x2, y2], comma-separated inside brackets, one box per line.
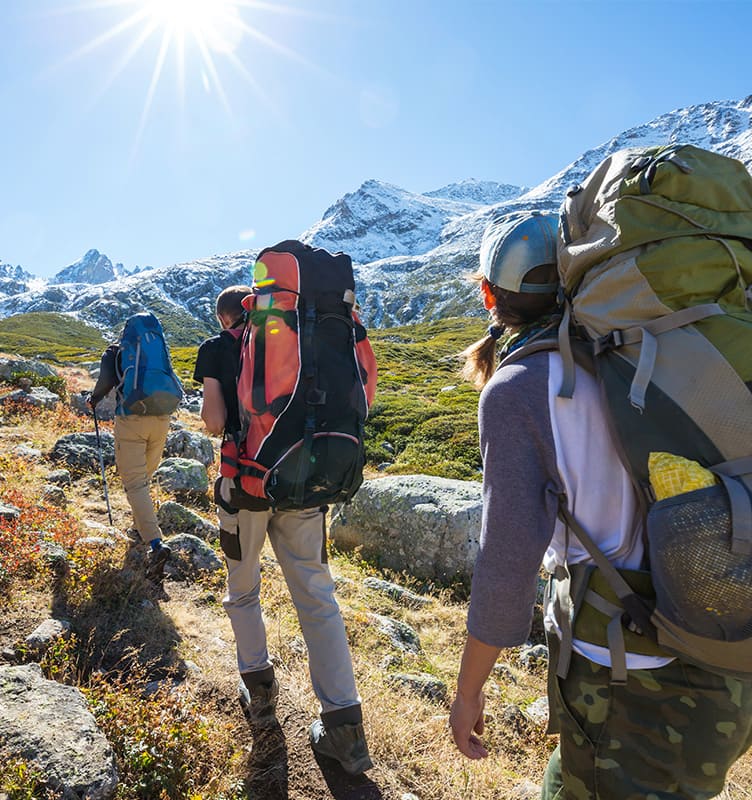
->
[220, 240, 376, 510]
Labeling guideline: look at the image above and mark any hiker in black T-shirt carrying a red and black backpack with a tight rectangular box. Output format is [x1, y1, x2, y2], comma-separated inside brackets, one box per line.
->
[194, 241, 376, 775]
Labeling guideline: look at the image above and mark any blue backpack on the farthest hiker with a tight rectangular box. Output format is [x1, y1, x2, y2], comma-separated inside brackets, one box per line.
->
[116, 311, 183, 416]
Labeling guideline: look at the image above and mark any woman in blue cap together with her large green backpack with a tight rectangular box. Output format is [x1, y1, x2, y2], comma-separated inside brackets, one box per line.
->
[450, 162, 752, 800]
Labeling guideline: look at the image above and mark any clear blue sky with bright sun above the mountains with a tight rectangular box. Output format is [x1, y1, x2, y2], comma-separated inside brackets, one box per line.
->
[0, 0, 752, 276]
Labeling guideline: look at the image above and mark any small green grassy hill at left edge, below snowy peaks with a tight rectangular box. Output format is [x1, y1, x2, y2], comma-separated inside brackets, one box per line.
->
[0, 311, 107, 362]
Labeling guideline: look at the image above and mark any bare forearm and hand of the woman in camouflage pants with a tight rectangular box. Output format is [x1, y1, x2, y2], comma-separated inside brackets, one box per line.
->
[449, 634, 501, 759]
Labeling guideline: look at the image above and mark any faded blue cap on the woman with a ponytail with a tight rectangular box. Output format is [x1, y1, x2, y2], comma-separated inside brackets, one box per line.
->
[480, 211, 558, 294]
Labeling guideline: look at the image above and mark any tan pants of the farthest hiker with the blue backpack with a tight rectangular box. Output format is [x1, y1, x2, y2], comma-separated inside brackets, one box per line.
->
[115, 414, 170, 542]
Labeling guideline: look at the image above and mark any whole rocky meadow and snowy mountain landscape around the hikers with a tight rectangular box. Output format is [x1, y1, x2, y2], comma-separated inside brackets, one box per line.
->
[0, 95, 752, 800]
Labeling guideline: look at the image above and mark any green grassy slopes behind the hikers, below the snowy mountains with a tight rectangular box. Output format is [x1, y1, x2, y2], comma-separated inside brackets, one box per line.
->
[0, 312, 484, 479]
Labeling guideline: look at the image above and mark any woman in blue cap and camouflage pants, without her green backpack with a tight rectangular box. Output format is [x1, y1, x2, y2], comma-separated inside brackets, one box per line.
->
[450, 203, 752, 800]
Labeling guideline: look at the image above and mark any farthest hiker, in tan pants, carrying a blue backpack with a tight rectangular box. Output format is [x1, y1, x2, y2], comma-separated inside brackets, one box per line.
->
[88, 312, 183, 591]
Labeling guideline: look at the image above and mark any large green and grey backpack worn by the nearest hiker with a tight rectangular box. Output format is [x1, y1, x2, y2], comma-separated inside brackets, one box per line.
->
[558, 145, 752, 682]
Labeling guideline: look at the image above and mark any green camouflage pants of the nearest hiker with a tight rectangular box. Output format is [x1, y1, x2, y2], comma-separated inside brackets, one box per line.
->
[541, 637, 752, 800]
